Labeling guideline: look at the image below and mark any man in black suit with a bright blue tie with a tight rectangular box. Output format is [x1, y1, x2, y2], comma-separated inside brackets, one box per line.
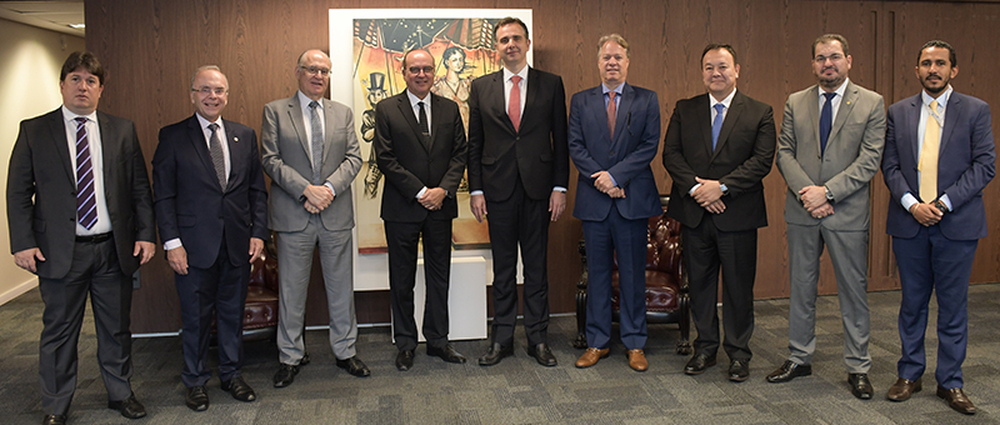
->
[663, 44, 775, 382]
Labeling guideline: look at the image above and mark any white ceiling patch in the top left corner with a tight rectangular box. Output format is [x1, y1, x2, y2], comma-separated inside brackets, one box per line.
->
[0, 0, 85, 37]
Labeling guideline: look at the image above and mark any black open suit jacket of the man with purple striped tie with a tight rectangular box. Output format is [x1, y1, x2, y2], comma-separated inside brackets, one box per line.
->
[7, 108, 156, 279]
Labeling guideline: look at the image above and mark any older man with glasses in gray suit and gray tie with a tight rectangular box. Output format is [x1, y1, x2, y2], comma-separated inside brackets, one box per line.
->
[261, 50, 371, 388]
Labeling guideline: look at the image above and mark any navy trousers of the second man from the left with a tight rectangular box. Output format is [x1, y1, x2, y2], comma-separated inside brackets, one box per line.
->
[174, 234, 250, 388]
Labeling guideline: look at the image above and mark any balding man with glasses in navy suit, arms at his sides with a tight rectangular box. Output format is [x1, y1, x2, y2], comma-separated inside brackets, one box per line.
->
[153, 65, 267, 411]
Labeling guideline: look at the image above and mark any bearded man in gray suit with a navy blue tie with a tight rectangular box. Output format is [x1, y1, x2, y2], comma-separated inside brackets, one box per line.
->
[767, 34, 885, 400]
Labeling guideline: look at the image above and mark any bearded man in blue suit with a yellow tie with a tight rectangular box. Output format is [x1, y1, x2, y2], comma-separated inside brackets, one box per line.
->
[882, 40, 996, 415]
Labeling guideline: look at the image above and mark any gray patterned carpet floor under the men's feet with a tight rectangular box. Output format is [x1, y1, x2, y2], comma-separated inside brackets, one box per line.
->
[0, 284, 1000, 425]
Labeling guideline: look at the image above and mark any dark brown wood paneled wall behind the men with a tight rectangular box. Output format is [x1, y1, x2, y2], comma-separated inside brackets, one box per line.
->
[86, 0, 1000, 332]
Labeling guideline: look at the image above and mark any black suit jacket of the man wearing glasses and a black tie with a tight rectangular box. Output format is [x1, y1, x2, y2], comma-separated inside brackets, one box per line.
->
[372, 90, 468, 223]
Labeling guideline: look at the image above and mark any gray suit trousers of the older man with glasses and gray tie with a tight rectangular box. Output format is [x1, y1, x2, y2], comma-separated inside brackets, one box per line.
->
[276, 214, 358, 365]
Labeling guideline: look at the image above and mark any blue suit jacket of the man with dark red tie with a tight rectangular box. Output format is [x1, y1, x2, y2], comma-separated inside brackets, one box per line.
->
[569, 83, 663, 221]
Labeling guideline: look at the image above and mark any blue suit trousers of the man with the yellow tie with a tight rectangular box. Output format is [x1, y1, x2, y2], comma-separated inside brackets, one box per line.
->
[892, 226, 979, 389]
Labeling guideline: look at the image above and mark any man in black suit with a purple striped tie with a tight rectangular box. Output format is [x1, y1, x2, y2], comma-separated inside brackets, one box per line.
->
[7, 52, 156, 424]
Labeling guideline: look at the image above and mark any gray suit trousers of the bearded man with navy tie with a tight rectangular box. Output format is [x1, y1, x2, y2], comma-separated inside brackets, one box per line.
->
[788, 223, 872, 373]
